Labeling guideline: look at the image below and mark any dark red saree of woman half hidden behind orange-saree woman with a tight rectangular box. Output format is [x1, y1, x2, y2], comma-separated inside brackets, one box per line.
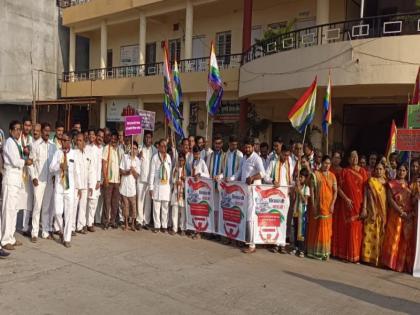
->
[331, 168, 346, 257]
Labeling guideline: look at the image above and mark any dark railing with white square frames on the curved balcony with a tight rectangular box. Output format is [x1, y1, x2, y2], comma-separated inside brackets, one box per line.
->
[244, 12, 420, 63]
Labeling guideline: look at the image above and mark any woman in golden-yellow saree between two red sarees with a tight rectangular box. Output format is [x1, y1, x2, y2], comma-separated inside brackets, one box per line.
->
[361, 162, 387, 266]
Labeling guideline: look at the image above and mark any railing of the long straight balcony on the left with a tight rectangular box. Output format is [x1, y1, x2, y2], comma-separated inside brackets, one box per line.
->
[63, 54, 242, 82]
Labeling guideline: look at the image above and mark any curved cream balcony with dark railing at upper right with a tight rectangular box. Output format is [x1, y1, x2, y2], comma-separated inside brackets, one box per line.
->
[239, 13, 420, 101]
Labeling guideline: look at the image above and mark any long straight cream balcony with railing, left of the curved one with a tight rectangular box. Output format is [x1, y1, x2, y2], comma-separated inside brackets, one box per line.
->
[61, 54, 242, 97]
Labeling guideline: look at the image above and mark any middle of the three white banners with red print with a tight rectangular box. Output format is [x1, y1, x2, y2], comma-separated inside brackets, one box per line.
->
[219, 182, 249, 242]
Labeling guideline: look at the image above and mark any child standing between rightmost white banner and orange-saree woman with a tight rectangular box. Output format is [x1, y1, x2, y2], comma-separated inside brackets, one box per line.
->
[291, 168, 310, 258]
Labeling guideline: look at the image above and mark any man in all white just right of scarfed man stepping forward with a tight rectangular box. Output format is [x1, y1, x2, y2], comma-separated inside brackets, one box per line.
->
[73, 132, 97, 234]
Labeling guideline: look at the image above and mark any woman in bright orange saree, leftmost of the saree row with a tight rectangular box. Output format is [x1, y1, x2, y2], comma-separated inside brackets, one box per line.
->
[307, 155, 337, 260]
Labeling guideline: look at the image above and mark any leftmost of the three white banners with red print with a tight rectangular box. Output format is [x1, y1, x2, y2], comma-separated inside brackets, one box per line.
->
[185, 177, 214, 233]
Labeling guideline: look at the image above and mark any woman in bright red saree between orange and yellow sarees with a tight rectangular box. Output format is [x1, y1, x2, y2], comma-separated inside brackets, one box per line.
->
[337, 151, 368, 263]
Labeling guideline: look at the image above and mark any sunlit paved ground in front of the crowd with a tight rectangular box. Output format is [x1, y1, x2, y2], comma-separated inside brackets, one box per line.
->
[0, 230, 420, 315]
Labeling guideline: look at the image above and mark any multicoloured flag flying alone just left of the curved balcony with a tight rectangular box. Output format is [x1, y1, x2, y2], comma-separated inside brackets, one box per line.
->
[206, 42, 223, 116]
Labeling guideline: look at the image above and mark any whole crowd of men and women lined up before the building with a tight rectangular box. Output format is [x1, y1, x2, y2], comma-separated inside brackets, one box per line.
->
[0, 119, 420, 272]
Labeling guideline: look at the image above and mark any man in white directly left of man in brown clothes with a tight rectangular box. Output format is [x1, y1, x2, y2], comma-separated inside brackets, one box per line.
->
[86, 129, 104, 232]
